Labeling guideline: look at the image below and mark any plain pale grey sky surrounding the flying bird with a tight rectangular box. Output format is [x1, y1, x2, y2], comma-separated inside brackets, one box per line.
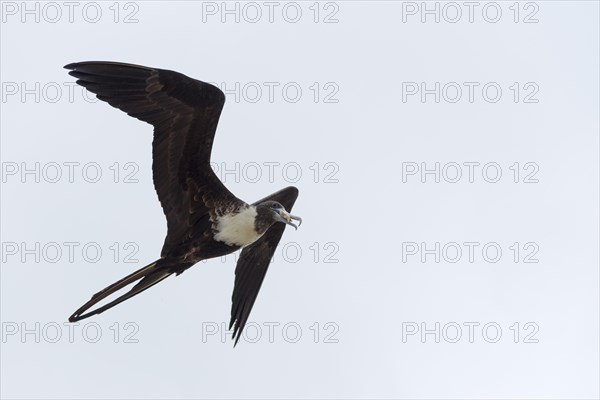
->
[0, 1, 600, 398]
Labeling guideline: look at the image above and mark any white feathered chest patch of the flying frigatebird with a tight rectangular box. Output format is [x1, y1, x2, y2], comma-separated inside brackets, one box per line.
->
[215, 206, 262, 246]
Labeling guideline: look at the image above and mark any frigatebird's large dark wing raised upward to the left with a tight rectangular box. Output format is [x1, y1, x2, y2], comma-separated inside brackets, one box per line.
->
[65, 61, 240, 256]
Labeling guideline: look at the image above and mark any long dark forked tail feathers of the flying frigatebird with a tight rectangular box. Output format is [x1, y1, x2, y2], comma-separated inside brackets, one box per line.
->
[69, 260, 173, 322]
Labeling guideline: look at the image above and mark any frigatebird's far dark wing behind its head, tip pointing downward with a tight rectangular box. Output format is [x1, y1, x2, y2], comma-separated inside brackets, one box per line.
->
[229, 186, 298, 344]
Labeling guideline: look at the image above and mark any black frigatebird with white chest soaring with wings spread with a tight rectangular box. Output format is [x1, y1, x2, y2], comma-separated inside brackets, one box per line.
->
[65, 61, 302, 344]
